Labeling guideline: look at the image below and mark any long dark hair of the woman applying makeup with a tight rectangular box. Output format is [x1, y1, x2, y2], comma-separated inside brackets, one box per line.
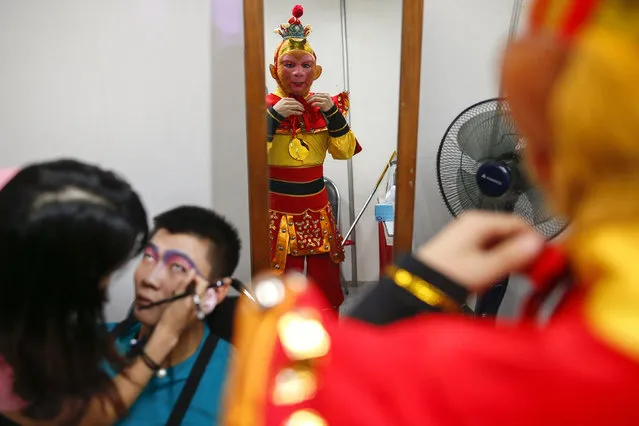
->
[0, 160, 148, 419]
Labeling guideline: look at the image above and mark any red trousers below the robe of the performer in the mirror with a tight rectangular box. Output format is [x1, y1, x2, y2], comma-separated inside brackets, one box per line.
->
[285, 253, 344, 309]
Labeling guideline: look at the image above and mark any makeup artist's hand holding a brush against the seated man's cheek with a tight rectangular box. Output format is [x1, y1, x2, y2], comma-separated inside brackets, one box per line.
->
[156, 270, 209, 336]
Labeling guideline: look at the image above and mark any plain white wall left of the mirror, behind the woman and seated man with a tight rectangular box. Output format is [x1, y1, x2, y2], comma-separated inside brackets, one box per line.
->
[0, 0, 248, 319]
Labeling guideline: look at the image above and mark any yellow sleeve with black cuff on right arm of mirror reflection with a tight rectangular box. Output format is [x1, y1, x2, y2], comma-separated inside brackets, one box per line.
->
[324, 93, 361, 160]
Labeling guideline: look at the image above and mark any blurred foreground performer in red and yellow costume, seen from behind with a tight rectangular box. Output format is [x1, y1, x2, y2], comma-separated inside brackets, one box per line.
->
[224, 0, 639, 426]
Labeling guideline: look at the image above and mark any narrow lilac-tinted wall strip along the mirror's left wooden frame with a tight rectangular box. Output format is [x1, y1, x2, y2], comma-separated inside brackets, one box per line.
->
[210, 0, 251, 290]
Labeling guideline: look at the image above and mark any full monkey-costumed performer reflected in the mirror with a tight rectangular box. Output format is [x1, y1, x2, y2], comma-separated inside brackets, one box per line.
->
[266, 5, 361, 308]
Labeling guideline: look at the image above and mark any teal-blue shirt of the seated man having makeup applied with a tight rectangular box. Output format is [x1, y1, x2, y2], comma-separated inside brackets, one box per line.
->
[107, 323, 231, 426]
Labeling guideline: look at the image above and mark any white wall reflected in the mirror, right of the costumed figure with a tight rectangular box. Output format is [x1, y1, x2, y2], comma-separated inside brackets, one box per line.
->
[346, 0, 402, 282]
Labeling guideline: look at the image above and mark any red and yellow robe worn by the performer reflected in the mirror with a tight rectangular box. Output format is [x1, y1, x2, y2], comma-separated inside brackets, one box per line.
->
[266, 90, 361, 272]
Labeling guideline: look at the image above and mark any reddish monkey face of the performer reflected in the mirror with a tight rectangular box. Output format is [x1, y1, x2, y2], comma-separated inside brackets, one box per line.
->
[277, 51, 318, 97]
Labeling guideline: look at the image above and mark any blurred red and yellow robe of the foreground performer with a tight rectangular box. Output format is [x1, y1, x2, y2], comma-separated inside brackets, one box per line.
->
[224, 226, 639, 426]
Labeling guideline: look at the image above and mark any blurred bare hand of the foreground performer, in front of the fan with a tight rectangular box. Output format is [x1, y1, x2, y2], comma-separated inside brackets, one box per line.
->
[416, 212, 544, 292]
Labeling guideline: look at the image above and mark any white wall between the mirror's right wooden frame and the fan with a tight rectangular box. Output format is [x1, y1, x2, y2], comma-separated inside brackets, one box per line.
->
[414, 0, 513, 244]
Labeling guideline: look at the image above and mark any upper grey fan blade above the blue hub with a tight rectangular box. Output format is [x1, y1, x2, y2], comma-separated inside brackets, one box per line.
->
[457, 109, 519, 161]
